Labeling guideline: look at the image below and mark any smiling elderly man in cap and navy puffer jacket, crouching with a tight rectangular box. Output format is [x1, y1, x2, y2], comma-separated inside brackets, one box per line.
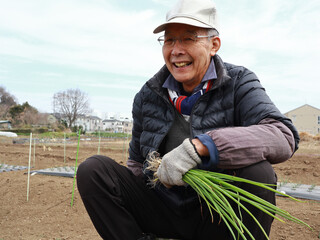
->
[77, 0, 299, 240]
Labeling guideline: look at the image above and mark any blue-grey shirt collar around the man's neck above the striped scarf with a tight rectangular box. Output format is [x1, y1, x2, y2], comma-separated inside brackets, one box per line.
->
[162, 59, 217, 93]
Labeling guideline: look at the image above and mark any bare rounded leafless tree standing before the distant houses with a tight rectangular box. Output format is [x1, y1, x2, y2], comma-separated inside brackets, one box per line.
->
[53, 89, 91, 128]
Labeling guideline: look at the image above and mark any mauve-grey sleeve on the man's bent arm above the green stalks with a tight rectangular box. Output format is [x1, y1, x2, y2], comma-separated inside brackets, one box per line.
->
[207, 118, 295, 169]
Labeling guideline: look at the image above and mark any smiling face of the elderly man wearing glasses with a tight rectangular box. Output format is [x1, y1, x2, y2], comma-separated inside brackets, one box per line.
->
[162, 24, 220, 92]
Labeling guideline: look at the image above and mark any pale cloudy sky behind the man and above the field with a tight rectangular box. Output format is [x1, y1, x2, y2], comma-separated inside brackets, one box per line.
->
[0, 0, 320, 117]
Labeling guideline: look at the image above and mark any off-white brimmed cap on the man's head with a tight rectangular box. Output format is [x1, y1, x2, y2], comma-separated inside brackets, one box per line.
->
[153, 0, 218, 33]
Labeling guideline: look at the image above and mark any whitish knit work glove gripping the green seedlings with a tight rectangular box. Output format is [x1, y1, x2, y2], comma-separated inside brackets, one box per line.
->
[156, 138, 201, 186]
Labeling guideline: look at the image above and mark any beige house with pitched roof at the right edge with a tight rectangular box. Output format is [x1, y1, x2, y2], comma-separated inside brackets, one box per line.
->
[284, 104, 320, 135]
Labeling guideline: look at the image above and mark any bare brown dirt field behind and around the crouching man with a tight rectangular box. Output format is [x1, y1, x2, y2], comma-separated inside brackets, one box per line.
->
[0, 136, 320, 240]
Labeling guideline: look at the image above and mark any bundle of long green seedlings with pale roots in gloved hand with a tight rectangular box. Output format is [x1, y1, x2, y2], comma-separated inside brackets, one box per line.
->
[147, 152, 312, 239]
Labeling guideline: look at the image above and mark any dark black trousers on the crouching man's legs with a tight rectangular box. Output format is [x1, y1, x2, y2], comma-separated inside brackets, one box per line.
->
[77, 155, 276, 240]
